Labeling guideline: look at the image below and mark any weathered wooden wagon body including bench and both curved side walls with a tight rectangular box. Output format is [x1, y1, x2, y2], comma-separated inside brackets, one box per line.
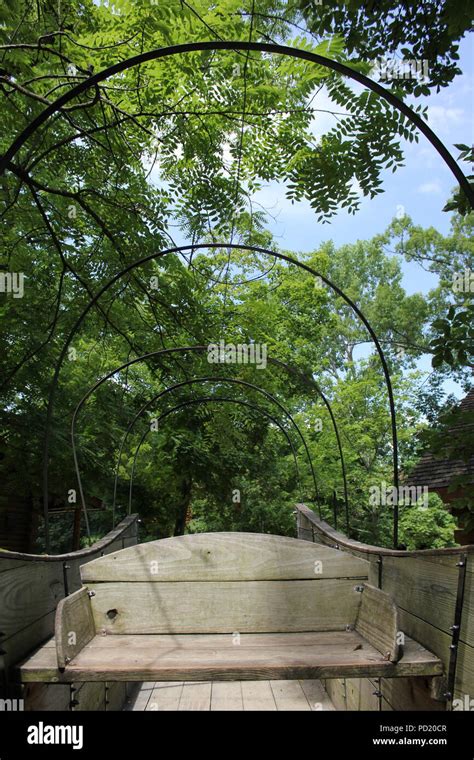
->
[0, 505, 473, 710]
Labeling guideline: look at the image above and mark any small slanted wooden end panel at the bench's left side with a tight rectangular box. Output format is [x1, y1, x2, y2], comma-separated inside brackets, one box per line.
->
[54, 588, 95, 668]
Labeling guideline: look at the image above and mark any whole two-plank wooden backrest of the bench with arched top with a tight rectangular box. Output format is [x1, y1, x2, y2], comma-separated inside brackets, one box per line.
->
[81, 533, 369, 634]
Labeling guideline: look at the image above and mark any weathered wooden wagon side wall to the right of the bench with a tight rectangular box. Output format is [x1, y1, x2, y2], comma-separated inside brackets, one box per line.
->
[297, 504, 474, 710]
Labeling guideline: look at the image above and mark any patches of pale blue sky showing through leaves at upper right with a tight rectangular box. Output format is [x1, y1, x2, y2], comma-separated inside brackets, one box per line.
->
[256, 35, 474, 293]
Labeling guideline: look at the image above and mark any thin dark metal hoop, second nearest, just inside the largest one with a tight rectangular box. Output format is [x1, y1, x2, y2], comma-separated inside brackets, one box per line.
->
[61, 243, 399, 546]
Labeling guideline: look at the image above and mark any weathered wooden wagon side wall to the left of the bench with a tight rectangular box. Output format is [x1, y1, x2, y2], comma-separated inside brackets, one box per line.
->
[0, 515, 138, 710]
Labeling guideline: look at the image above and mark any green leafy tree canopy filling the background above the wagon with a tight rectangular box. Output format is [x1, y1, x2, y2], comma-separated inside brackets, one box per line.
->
[0, 0, 473, 551]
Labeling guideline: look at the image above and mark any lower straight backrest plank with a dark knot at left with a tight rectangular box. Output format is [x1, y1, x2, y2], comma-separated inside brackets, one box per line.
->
[89, 579, 360, 634]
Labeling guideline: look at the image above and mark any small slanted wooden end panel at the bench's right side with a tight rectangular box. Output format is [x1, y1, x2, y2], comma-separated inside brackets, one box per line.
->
[355, 584, 400, 662]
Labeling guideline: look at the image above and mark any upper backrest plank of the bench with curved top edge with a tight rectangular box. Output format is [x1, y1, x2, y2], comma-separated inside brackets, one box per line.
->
[81, 533, 369, 583]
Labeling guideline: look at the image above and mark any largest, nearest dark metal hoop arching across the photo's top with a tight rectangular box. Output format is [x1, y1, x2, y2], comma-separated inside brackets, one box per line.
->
[0, 40, 474, 202]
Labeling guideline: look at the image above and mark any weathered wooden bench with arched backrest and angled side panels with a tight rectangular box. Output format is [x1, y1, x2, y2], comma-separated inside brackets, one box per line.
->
[17, 533, 442, 683]
